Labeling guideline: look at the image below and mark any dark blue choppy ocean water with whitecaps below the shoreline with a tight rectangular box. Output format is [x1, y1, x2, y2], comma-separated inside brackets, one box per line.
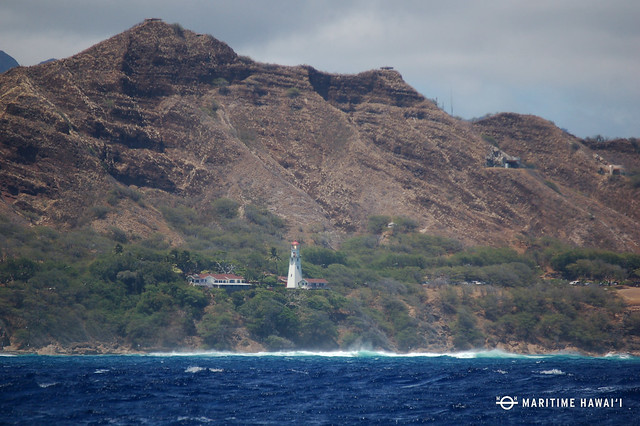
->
[0, 352, 640, 425]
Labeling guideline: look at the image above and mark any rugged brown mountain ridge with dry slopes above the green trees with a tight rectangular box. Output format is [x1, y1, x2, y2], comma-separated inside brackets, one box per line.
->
[0, 19, 640, 252]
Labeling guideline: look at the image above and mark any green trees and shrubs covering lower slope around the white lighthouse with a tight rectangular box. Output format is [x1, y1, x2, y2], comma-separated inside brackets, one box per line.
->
[0, 198, 640, 352]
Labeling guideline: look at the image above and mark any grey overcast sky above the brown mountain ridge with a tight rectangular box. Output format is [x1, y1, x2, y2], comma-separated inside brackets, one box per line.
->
[0, 0, 640, 137]
